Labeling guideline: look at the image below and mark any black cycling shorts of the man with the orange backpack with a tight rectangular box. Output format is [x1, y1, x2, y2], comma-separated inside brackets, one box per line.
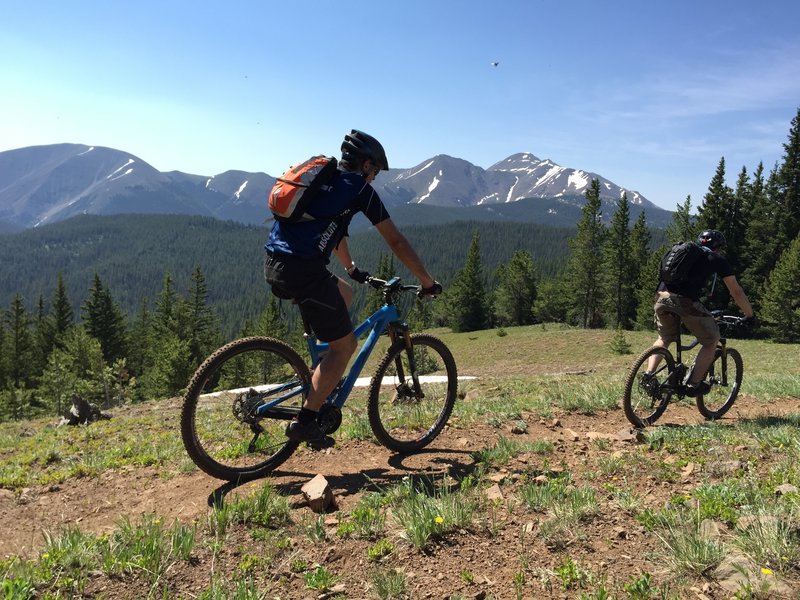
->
[264, 253, 353, 342]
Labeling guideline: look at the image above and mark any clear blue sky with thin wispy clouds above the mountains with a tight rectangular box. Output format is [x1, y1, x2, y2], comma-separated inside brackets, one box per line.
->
[0, 0, 800, 210]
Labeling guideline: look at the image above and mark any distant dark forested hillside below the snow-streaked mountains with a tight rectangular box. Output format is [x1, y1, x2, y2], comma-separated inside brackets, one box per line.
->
[0, 215, 592, 335]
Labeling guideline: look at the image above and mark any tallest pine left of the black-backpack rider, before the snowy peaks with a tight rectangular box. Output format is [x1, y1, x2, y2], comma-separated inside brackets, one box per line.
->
[566, 179, 605, 327]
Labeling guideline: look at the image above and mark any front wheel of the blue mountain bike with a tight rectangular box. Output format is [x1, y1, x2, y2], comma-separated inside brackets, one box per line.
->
[367, 334, 458, 452]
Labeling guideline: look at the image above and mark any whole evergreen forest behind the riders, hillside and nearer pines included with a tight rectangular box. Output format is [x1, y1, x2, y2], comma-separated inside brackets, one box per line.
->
[0, 110, 800, 420]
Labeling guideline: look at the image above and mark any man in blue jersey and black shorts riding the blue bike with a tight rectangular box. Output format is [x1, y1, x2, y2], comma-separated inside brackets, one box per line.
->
[264, 129, 442, 448]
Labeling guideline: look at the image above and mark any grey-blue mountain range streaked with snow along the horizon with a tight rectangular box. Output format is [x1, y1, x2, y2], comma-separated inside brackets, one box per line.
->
[0, 144, 667, 231]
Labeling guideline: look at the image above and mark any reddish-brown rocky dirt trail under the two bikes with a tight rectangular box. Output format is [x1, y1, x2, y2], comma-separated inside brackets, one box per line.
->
[0, 396, 800, 556]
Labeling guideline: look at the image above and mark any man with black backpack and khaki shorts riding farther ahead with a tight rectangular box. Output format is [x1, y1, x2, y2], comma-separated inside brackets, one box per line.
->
[644, 229, 754, 396]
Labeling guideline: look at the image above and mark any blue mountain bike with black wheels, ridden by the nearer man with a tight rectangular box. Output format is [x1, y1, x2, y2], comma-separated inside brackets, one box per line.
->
[181, 277, 457, 481]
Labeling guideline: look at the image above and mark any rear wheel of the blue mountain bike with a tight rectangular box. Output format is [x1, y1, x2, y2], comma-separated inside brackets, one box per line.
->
[181, 337, 311, 481]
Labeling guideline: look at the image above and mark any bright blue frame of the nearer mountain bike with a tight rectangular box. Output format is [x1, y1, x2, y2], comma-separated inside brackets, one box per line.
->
[255, 282, 416, 416]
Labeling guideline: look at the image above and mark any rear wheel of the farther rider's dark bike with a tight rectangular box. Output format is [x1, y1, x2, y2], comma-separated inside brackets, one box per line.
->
[622, 348, 677, 428]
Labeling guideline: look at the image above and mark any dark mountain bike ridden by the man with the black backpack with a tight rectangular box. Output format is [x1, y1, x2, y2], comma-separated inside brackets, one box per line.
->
[622, 311, 744, 428]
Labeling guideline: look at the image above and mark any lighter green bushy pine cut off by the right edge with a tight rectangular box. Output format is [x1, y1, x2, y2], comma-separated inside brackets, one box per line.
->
[762, 234, 800, 343]
